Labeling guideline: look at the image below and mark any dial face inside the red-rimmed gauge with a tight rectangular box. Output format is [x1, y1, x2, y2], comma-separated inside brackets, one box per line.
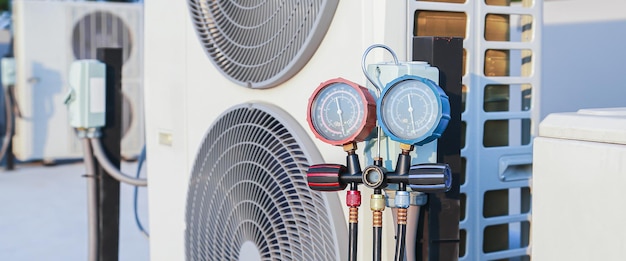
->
[311, 83, 365, 141]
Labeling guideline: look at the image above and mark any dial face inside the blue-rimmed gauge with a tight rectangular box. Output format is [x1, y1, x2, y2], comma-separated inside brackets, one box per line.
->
[380, 79, 440, 140]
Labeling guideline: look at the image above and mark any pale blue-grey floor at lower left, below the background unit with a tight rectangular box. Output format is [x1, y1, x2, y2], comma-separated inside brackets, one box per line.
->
[0, 159, 150, 261]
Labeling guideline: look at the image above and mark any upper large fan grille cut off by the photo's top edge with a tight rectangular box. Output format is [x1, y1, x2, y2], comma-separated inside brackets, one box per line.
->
[188, 0, 337, 88]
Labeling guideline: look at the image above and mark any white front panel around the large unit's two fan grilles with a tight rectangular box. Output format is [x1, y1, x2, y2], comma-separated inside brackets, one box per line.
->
[145, 0, 416, 260]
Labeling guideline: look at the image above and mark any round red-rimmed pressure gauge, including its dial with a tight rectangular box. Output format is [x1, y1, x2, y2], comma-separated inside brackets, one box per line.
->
[307, 78, 376, 146]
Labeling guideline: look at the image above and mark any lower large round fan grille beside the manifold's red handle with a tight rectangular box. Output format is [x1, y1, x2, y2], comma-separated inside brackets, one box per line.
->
[186, 104, 339, 261]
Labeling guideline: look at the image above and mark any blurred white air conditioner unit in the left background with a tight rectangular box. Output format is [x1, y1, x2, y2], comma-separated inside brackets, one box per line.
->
[13, 0, 144, 161]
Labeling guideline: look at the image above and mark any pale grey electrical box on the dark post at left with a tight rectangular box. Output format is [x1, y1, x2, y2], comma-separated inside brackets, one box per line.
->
[65, 60, 106, 129]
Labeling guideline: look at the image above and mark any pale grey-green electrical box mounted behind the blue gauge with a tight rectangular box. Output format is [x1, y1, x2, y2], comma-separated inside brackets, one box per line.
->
[364, 61, 439, 169]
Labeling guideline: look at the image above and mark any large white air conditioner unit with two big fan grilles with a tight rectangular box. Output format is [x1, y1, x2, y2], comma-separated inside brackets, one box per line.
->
[145, 0, 412, 260]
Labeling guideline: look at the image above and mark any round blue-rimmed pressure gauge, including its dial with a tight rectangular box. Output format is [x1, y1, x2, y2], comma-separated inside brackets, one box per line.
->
[376, 75, 450, 146]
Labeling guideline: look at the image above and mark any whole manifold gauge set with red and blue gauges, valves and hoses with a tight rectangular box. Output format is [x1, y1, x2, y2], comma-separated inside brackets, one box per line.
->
[307, 45, 452, 261]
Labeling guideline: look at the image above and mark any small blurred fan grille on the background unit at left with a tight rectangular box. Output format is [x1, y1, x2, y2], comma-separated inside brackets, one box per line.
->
[72, 11, 133, 62]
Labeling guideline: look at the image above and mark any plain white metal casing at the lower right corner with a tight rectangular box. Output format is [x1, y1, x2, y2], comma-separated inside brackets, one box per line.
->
[532, 107, 626, 261]
